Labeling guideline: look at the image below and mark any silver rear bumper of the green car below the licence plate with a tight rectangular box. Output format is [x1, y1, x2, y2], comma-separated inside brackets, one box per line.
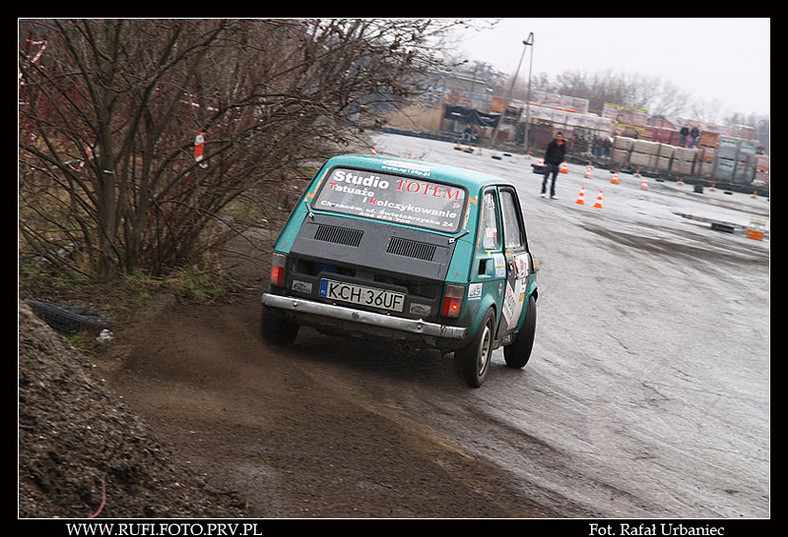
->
[262, 293, 467, 340]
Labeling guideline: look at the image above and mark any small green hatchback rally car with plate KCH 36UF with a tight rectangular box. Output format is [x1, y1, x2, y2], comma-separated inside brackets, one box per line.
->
[261, 155, 538, 387]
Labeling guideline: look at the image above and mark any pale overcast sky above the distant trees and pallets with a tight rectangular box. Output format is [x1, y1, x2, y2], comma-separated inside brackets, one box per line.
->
[450, 18, 771, 115]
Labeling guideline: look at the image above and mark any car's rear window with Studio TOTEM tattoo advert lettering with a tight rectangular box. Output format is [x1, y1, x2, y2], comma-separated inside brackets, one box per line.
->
[312, 168, 467, 233]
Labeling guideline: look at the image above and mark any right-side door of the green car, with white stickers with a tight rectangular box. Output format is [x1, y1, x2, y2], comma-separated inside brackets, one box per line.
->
[498, 186, 530, 339]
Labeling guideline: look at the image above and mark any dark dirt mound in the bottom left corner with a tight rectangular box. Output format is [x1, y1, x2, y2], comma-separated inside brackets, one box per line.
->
[19, 304, 243, 518]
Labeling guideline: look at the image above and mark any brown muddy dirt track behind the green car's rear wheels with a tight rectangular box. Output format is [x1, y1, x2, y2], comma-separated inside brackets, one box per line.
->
[100, 282, 582, 518]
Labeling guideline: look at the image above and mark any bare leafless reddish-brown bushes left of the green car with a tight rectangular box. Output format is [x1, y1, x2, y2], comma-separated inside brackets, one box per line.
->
[19, 19, 462, 278]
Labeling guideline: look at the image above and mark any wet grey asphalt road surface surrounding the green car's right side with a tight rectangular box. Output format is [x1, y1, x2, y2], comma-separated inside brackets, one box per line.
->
[315, 131, 770, 518]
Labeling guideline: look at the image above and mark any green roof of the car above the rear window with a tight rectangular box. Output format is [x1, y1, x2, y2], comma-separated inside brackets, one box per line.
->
[326, 154, 511, 191]
